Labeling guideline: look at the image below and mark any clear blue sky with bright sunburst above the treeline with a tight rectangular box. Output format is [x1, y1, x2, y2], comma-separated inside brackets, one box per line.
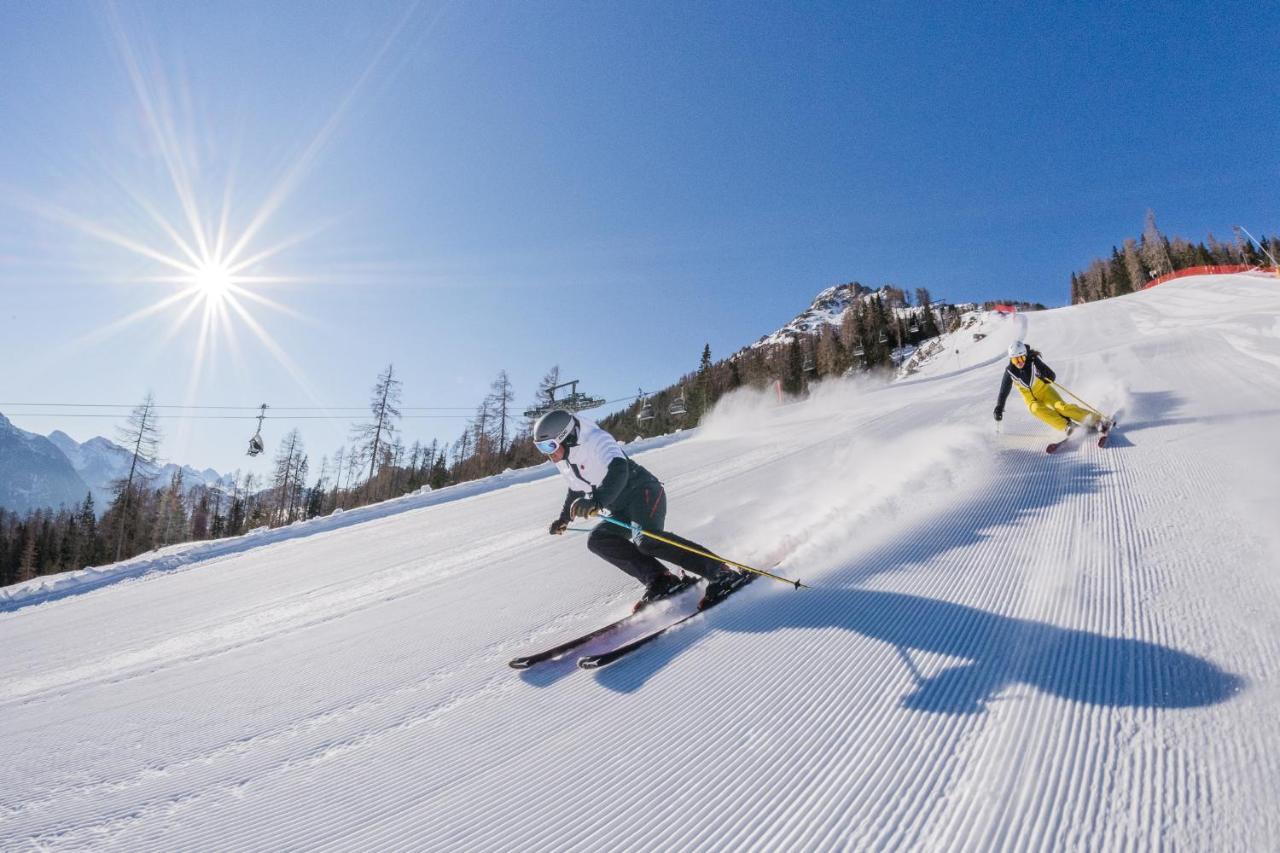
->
[0, 3, 1280, 470]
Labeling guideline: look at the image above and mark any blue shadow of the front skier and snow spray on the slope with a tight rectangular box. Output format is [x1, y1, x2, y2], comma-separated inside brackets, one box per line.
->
[586, 451, 1244, 713]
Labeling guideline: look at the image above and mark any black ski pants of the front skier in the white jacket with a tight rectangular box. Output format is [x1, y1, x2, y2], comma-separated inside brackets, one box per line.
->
[586, 479, 724, 587]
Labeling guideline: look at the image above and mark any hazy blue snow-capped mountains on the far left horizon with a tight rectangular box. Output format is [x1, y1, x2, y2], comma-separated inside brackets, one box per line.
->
[0, 415, 233, 515]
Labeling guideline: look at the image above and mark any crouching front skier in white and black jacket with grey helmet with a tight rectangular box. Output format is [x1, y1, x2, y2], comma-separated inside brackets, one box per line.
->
[534, 409, 740, 608]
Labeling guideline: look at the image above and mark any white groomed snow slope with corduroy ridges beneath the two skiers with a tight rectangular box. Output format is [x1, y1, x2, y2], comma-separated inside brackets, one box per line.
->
[0, 275, 1280, 850]
